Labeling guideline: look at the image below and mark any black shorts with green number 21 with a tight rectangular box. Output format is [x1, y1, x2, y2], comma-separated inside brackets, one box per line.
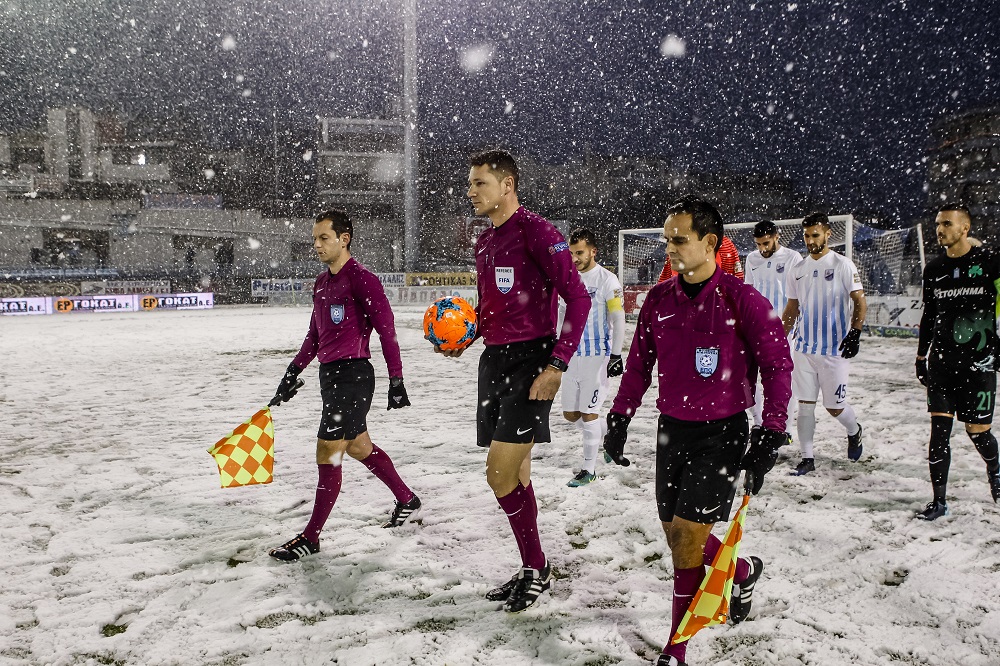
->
[927, 365, 997, 425]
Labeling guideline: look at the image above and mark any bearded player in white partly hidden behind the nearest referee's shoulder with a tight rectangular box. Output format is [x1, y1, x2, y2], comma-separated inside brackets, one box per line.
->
[744, 220, 802, 432]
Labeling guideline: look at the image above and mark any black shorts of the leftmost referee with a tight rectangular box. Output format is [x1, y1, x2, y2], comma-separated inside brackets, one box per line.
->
[316, 358, 375, 440]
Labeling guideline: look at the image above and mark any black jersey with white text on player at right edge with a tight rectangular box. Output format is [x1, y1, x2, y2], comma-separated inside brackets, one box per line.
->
[917, 247, 1000, 370]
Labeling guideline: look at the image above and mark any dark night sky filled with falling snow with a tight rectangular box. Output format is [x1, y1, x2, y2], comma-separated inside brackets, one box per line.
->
[0, 0, 1000, 224]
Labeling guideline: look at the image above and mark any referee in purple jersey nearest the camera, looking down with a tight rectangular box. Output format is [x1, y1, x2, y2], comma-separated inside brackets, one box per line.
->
[604, 197, 792, 666]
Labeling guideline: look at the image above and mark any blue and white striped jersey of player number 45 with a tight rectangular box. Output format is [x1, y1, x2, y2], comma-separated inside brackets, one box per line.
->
[785, 251, 861, 356]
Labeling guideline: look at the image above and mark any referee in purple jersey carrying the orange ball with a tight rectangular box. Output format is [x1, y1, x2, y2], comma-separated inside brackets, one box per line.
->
[437, 150, 590, 613]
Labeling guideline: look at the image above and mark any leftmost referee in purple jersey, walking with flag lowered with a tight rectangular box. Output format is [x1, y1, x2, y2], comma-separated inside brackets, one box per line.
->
[270, 210, 420, 561]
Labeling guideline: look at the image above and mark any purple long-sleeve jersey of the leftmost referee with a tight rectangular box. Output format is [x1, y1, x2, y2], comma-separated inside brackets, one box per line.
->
[292, 257, 403, 377]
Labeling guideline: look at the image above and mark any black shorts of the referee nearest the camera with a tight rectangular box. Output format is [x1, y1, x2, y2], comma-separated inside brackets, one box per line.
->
[656, 412, 750, 524]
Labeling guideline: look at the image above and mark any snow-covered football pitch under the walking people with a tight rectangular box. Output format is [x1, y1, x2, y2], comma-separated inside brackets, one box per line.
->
[0, 307, 1000, 666]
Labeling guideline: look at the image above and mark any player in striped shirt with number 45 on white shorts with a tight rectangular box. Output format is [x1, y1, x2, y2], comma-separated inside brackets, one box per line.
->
[782, 213, 868, 475]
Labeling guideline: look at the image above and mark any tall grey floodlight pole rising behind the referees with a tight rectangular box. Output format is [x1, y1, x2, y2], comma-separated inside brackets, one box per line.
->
[403, 0, 420, 272]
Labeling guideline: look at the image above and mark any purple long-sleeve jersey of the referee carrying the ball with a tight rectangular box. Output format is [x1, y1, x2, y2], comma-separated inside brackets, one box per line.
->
[476, 206, 590, 363]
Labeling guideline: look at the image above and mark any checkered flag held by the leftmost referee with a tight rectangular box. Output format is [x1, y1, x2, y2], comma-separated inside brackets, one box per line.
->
[208, 407, 274, 488]
